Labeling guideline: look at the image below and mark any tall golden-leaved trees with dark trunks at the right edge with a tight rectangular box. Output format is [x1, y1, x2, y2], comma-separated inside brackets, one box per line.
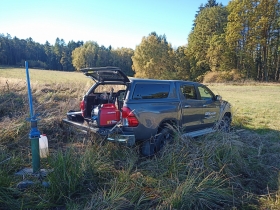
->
[226, 0, 279, 81]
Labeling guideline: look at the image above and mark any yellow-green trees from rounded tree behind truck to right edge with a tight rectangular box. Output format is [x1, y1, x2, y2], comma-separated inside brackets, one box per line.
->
[132, 0, 280, 81]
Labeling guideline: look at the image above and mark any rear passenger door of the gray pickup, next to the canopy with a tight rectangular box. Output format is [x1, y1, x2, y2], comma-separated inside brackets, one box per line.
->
[179, 83, 204, 132]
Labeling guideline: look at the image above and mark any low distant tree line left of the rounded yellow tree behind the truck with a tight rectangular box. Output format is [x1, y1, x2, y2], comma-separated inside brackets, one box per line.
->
[0, 34, 134, 76]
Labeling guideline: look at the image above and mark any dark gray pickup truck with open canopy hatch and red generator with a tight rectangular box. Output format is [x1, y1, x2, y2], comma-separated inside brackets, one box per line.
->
[63, 67, 232, 155]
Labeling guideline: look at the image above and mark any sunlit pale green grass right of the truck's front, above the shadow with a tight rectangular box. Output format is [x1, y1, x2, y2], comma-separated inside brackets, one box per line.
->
[209, 83, 280, 132]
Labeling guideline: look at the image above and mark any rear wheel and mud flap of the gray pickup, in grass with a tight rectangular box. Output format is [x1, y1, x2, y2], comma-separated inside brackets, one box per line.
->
[142, 128, 173, 156]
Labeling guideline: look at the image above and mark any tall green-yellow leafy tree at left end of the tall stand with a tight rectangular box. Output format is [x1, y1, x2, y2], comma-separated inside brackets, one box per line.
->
[186, 6, 227, 79]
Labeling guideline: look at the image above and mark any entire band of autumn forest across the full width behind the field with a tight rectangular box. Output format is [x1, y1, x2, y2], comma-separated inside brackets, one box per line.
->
[0, 0, 280, 82]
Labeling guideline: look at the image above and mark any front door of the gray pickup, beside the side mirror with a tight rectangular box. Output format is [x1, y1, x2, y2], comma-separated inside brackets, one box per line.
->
[198, 85, 220, 128]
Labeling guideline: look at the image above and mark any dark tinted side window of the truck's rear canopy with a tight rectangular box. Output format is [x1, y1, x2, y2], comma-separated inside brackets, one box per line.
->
[132, 84, 170, 99]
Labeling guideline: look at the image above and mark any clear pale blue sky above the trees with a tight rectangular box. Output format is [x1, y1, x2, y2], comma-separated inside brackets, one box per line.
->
[0, 0, 230, 49]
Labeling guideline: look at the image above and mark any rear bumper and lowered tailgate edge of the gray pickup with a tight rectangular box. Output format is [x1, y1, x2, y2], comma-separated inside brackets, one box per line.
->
[62, 119, 135, 146]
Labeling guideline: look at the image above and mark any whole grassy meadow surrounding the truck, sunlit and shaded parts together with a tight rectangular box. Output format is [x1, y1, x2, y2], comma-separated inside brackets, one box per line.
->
[0, 67, 280, 210]
